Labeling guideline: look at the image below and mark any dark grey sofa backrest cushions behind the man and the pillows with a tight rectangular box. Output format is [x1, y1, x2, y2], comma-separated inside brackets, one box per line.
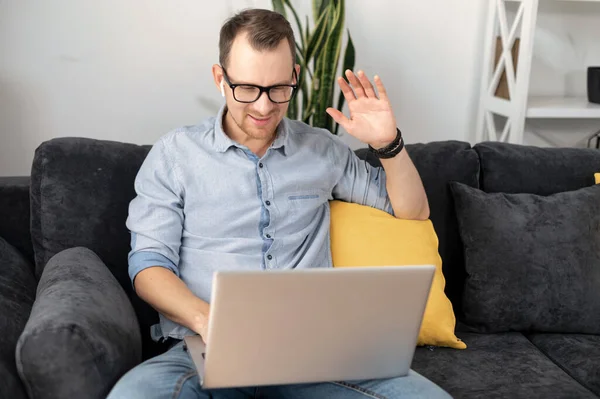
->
[30, 138, 600, 358]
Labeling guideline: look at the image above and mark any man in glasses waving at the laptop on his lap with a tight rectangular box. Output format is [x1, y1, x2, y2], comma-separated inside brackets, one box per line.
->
[109, 10, 447, 399]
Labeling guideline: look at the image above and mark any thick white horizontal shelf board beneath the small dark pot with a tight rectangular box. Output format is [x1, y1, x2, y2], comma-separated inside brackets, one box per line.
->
[527, 96, 600, 119]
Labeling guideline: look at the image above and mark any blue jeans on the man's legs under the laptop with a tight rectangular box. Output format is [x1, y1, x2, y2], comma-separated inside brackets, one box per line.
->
[107, 342, 451, 399]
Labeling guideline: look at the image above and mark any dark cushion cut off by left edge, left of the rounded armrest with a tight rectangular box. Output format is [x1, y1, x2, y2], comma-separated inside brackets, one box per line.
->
[0, 237, 36, 399]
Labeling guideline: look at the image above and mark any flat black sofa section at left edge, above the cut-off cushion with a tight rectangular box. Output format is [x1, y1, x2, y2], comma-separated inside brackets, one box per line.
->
[0, 176, 33, 264]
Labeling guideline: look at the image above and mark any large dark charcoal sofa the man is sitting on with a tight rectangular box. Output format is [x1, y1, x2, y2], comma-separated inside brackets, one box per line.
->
[0, 137, 600, 399]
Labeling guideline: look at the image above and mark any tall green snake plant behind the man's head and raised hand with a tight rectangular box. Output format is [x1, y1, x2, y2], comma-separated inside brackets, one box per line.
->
[272, 0, 354, 134]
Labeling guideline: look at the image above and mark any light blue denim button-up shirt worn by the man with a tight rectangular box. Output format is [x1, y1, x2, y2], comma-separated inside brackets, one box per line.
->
[127, 107, 393, 339]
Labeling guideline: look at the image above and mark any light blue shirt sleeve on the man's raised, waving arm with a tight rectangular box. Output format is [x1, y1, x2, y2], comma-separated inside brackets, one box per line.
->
[332, 137, 394, 215]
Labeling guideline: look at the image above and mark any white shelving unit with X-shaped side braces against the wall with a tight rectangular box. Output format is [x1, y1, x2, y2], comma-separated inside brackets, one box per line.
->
[476, 0, 600, 144]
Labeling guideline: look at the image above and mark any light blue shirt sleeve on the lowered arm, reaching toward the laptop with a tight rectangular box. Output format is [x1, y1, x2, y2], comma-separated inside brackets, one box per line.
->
[126, 136, 183, 290]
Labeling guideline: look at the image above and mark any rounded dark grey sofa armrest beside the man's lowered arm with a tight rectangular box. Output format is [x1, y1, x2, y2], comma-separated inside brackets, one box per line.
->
[16, 247, 142, 399]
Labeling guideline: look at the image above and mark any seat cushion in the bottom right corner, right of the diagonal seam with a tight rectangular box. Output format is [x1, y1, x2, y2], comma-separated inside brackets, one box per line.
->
[527, 334, 600, 396]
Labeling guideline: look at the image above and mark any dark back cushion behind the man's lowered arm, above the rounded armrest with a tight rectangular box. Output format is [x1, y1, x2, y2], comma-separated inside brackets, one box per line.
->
[31, 138, 165, 359]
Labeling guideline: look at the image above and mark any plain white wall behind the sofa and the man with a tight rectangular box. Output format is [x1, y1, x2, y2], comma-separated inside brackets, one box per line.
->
[0, 0, 486, 176]
